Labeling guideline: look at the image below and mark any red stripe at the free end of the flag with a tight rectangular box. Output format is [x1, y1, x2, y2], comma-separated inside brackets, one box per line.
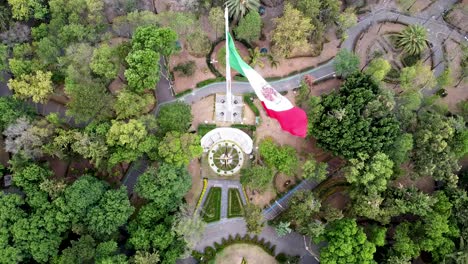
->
[262, 102, 308, 138]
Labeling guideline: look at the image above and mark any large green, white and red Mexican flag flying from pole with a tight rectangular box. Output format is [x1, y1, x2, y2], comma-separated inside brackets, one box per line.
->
[227, 34, 307, 137]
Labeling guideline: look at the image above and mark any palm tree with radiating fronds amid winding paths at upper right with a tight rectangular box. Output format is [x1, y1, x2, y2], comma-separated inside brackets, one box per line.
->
[397, 25, 427, 55]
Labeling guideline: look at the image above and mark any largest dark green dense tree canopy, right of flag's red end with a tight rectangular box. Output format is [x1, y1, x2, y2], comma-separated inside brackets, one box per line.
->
[311, 73, 399, 158]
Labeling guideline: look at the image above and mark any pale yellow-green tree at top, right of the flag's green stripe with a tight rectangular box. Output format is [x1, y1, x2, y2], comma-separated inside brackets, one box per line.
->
[271, 4, 314, 57]
